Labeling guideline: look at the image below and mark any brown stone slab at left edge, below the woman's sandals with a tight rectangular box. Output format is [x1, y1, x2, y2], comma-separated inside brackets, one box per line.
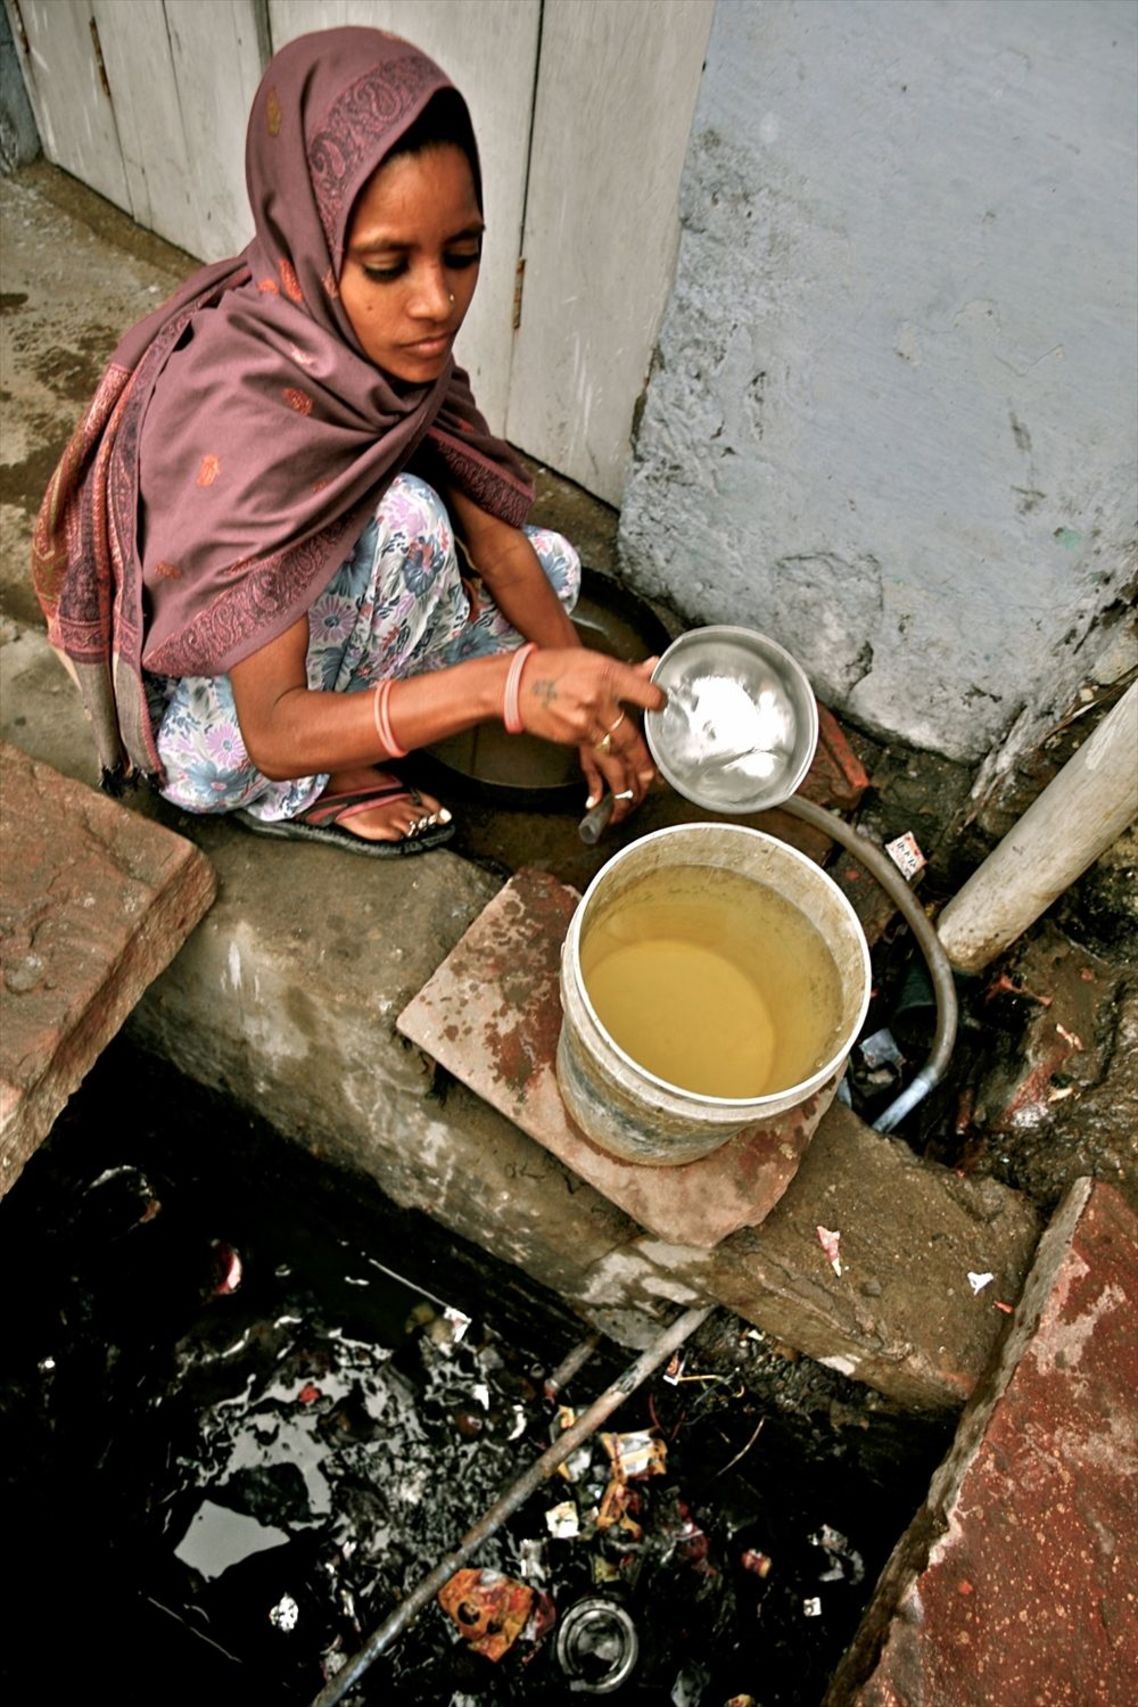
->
[0, 744, 215, 1193]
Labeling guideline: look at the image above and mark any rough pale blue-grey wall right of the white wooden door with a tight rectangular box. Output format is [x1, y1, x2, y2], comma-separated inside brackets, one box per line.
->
[621, 0, 1138, 760]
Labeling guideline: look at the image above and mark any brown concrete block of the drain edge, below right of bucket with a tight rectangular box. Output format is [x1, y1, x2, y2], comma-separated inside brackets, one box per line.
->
[711, 1103, 1039, 1410]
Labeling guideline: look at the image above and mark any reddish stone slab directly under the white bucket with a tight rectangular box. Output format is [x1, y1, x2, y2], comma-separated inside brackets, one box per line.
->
[398, 869, 832, 1246]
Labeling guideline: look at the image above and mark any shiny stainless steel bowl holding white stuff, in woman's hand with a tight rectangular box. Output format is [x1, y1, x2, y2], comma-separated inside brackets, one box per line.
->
[645, 625, 817, 816]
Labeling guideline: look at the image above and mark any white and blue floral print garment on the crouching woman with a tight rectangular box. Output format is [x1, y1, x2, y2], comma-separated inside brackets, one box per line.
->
[147, 475, 580, 823]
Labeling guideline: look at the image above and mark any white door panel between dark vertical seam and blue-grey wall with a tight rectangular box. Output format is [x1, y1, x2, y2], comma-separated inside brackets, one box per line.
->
[505, 0, 715, 504]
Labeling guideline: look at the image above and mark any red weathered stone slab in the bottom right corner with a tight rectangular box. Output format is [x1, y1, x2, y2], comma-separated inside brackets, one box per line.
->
[826, 1180, 1138, 1707]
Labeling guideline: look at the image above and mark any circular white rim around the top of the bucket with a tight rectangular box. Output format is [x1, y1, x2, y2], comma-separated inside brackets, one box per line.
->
[565, 819, 874, 1120]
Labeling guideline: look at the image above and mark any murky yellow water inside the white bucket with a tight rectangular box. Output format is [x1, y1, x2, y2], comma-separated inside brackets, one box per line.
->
[580, 865, 841, 1098]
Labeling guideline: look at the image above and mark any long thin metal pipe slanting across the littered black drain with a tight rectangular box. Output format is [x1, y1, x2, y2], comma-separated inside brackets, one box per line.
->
[312, 1304, 715, 1707]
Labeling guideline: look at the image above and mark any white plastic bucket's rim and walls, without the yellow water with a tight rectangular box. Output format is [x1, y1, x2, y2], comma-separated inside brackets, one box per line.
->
[556, 824, 870, 1168]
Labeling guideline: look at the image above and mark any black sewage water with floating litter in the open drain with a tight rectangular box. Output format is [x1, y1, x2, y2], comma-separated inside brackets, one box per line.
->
[0, 1041, 947, 1707]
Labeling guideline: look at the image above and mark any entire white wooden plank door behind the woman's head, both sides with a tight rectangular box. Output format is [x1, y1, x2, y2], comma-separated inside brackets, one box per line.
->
[5, 0, 715, 504]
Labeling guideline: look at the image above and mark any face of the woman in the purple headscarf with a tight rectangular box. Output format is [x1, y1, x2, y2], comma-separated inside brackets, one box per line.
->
[340, 143, 483, 384]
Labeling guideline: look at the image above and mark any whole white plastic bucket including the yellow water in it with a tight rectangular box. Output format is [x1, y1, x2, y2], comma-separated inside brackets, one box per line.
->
[556, 824, 870, 1168]
